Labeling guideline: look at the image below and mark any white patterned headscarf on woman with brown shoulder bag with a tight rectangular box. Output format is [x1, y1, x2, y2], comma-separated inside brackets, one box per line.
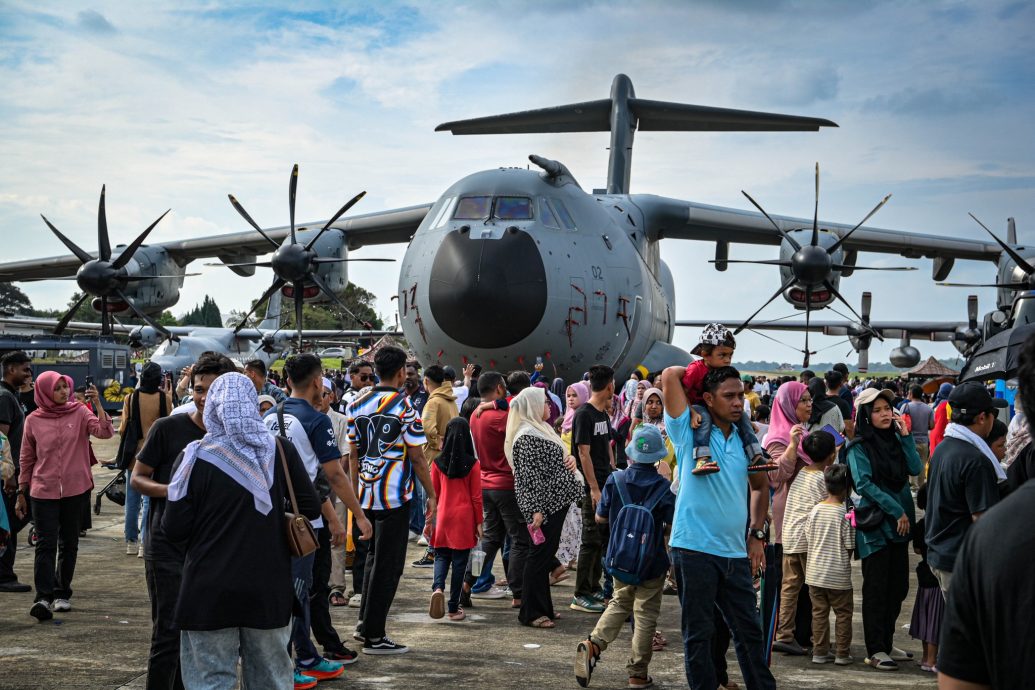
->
[169, 372, 276, 515]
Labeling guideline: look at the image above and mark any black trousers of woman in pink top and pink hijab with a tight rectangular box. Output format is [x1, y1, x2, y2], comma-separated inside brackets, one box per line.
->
[32, 491, 90, 601]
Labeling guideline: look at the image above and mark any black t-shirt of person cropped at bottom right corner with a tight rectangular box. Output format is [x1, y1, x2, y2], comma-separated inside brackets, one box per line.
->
[938, 477, 1035, 689]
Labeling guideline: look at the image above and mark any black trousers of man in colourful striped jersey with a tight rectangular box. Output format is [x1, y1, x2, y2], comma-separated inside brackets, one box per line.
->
[359, 501, 410, 639]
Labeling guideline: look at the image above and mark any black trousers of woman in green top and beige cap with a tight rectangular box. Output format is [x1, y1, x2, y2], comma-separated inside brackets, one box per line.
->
[862, 541, 909, 657]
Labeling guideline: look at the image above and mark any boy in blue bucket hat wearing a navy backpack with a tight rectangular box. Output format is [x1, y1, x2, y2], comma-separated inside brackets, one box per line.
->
[574, 424, 676, 688]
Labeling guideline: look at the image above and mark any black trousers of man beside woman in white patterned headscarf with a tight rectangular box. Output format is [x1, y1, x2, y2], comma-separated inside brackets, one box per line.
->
[144, 559, 183, 690]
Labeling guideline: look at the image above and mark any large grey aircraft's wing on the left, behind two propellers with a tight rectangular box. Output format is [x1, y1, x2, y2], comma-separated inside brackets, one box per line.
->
[0, 204, 433, 281]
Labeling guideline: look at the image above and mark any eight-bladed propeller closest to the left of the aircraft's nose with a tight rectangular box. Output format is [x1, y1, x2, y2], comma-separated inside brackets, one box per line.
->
[225, 163, 385, 348]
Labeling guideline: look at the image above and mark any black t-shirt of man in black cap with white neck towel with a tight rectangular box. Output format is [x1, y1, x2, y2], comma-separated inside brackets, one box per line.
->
[925, 438, 999, 571]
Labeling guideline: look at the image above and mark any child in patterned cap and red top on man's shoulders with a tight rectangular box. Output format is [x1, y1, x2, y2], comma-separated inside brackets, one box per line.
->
[683, 324, 776, 476]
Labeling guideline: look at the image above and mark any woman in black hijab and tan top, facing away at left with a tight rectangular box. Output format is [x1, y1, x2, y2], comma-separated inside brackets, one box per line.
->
[119, 362, 174, 558]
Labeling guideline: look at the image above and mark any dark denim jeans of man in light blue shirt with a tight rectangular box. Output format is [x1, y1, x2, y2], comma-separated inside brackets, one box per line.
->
[672, 548, 776, 690]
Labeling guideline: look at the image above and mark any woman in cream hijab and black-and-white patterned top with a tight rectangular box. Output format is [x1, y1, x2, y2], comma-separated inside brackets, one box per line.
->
[503, 388, 586, 628]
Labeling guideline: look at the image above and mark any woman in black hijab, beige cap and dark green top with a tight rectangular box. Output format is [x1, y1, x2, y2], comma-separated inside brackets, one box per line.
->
[848, 388, 923, 670]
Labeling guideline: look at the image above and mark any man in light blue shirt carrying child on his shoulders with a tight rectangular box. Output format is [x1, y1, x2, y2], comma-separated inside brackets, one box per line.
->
[661, 366, 776, 690]
